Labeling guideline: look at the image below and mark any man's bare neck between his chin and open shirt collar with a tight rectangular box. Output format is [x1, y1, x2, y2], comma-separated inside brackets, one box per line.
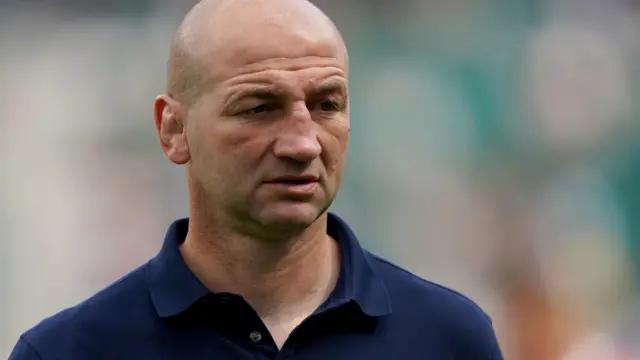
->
[181, 214, 340, 319]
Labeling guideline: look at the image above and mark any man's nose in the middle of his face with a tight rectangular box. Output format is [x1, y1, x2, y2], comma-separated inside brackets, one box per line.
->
[273, 106, 322, 163]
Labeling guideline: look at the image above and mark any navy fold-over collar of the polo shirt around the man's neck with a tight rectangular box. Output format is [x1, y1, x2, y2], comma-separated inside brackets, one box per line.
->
[147, 213, 391, 317]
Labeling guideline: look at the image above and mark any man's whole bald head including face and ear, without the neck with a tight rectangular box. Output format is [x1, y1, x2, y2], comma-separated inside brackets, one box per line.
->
[155, 0, 350, 237]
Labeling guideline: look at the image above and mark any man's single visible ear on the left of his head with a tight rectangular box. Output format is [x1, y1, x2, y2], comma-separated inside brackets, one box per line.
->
[153, 95, 191, 165]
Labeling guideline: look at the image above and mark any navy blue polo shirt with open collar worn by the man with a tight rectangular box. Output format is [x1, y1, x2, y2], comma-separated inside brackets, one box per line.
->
[10, 214, 502, 360]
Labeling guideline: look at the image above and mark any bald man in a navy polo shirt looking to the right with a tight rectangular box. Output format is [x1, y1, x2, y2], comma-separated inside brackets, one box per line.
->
[6, 0, 502, 360]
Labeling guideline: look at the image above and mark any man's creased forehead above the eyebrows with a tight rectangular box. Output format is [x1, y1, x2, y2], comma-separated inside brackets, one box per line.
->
[195, 2, 348, 83]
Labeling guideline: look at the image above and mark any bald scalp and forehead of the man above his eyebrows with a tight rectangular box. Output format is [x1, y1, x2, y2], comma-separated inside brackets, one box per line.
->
[167, 0, 347, 102]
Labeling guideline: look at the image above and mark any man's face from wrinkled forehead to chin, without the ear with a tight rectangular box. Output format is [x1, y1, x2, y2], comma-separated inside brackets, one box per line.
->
[180, 16, 350, 236]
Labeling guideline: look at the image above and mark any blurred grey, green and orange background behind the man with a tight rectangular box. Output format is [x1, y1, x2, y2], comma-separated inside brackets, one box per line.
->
[0, 0, 640, 360]
